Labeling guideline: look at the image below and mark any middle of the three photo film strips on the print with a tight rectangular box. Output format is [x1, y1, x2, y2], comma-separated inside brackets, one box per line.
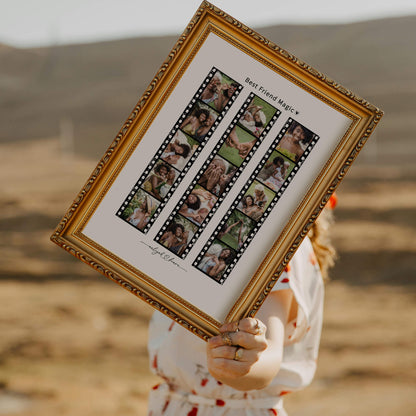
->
[155, 93, 281, 258]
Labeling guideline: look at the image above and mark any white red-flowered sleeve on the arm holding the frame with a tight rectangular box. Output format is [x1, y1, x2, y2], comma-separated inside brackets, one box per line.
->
[273, 238, 323, 342]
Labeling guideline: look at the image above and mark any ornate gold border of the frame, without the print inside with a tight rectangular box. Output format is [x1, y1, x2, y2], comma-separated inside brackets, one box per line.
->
[51, 1, 383, 340]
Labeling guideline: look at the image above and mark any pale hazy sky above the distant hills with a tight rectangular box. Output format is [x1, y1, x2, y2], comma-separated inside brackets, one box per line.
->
[0, 0, 416, 47]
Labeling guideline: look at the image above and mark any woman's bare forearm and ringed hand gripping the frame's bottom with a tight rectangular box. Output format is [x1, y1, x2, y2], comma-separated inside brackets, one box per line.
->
[207, 289, 293, 391]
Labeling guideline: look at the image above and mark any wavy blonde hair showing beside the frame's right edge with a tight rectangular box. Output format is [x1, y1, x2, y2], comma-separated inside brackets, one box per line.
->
[308, 208, 337, 280]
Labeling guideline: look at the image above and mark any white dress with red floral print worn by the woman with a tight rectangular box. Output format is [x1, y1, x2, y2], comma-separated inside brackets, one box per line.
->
[148, 239, 324, 416]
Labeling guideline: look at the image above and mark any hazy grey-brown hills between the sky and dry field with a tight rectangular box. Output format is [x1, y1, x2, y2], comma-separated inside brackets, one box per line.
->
[0, 16, 416, 161]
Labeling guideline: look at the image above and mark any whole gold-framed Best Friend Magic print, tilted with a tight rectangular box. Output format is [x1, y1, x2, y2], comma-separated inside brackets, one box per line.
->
[51, 1, 383, 340]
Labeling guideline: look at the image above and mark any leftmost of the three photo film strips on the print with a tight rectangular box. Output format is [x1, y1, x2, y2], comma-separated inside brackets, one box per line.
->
[116, 67, 243, 233]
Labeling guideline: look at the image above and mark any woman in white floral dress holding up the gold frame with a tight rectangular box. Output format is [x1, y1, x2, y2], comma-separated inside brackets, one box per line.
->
[148, 206, 334, 416]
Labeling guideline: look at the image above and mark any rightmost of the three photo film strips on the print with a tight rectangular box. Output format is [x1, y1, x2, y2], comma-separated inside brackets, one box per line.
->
[192, 118, 319, 284]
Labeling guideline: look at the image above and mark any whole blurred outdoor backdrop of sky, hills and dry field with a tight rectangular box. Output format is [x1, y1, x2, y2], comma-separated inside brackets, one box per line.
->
[0, 0, 416, 416]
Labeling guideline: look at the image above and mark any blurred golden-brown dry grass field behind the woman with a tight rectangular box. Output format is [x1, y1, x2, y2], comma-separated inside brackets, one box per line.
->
[0, 139, 416, 416]
